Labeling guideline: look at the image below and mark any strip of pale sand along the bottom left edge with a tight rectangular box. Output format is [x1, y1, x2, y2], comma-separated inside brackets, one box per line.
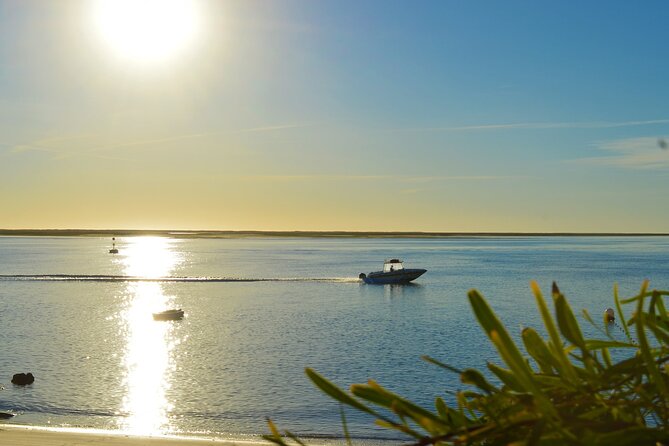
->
[0, 425, 269, 446]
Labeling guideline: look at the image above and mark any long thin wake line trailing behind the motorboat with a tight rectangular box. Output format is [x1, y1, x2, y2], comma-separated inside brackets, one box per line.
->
[0, 274, 360, 283]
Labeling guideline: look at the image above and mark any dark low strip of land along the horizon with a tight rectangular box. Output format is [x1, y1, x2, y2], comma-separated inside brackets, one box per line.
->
[0, 229, 669, 239]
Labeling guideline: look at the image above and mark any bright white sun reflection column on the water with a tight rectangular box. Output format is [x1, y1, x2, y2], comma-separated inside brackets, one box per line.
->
[120, 237, 181, 435]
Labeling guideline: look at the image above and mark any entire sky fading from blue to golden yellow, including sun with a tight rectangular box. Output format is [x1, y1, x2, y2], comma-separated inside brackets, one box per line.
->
[0, 0, 669, 232]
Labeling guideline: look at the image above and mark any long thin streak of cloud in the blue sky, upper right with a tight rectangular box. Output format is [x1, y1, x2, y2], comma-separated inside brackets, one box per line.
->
[394, 119, 669, 132]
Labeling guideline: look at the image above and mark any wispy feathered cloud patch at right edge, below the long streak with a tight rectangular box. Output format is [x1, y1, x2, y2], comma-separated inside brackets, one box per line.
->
[573, 137, 669, 169]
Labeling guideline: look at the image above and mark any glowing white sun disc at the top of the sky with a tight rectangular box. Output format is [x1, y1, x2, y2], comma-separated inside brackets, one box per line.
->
[93, 0, 200, 63]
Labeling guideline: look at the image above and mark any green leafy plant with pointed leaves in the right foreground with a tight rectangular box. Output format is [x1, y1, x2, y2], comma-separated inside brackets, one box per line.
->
[264, 282, 669, 446]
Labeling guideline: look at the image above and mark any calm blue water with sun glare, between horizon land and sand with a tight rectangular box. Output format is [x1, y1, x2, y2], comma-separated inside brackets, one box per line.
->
[0, 237, 669, 442]
